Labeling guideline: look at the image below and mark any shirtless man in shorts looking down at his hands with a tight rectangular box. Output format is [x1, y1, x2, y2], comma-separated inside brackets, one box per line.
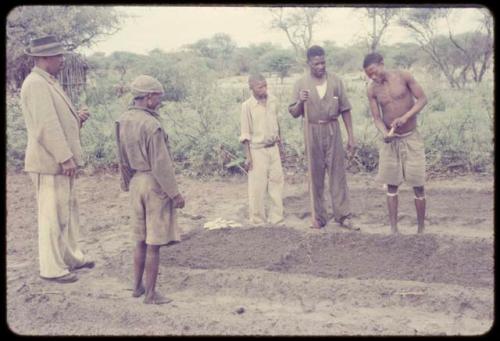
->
[363, 53, 427, 233]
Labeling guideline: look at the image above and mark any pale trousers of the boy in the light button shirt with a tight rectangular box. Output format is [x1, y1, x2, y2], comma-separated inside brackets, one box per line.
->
[248, 145, 285, 225]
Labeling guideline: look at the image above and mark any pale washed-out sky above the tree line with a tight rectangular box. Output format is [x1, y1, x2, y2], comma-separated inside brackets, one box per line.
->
[81, 6, 486, 54]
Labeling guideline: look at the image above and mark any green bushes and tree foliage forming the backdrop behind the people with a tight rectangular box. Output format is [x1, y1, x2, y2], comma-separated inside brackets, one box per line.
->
[6, 6, 494, 176]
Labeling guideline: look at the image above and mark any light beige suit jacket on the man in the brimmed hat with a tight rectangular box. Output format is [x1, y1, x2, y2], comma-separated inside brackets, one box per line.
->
[21, 66, 83, 174]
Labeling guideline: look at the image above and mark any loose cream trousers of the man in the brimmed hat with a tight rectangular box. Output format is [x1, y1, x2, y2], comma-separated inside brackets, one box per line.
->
[30, 173, 85, 278]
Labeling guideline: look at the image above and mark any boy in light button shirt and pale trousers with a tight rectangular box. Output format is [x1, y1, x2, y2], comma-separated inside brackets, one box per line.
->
[240, 74, 284, 225]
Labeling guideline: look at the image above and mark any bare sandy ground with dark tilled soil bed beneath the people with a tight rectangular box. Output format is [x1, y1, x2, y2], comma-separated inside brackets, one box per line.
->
[6, 173, 494, 335]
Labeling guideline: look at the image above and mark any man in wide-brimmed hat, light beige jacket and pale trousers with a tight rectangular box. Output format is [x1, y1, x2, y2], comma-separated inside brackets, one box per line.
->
[21, 36, 94, 283]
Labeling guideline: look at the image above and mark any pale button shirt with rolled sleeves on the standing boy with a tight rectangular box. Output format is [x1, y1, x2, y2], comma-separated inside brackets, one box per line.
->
[240, 95, 279, 149]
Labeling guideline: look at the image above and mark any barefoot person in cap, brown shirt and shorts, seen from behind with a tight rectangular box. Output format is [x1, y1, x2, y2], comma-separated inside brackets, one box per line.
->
[116, 75, 184, 304]
